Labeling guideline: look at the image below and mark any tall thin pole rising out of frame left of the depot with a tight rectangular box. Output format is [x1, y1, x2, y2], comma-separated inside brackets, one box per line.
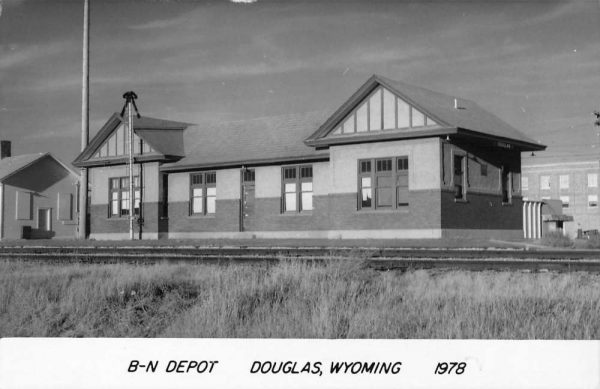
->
[78, 0, 90, 239]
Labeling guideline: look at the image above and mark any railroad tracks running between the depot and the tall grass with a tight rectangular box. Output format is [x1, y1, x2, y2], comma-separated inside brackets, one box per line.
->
[0, 246, 600, 272]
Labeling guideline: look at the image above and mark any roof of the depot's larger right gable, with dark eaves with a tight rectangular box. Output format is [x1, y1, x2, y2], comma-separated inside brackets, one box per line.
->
[306, 75, 545, 150]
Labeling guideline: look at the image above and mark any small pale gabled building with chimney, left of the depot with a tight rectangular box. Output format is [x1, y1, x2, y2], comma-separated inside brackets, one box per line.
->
[0, 141, 79, 240]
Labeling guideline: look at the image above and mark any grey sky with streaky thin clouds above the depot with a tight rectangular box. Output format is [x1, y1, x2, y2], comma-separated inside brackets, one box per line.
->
[0, 0, 600, 162]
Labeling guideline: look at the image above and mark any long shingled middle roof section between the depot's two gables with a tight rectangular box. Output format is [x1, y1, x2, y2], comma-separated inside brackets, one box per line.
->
[161, 111, 328, 171]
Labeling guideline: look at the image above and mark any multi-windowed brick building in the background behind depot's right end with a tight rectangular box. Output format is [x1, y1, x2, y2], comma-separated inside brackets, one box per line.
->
[521, 157, 600, 237]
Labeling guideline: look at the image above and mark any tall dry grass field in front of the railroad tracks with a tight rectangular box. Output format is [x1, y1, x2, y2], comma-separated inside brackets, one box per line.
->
[0, 260, 600, 339]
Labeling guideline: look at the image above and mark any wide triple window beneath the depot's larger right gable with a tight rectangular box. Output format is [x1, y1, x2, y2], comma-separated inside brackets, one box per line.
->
[358, 157, 408, 209]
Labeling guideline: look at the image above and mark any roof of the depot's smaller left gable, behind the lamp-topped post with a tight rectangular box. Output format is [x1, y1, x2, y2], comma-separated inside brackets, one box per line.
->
[73, 112, 190, 166]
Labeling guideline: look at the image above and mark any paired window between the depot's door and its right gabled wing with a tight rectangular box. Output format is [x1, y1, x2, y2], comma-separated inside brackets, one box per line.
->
[281, 165, 313, 212]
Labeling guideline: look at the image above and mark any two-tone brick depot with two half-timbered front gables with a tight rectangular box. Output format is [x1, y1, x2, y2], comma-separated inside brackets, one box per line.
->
[74, 75, 545, 239]
